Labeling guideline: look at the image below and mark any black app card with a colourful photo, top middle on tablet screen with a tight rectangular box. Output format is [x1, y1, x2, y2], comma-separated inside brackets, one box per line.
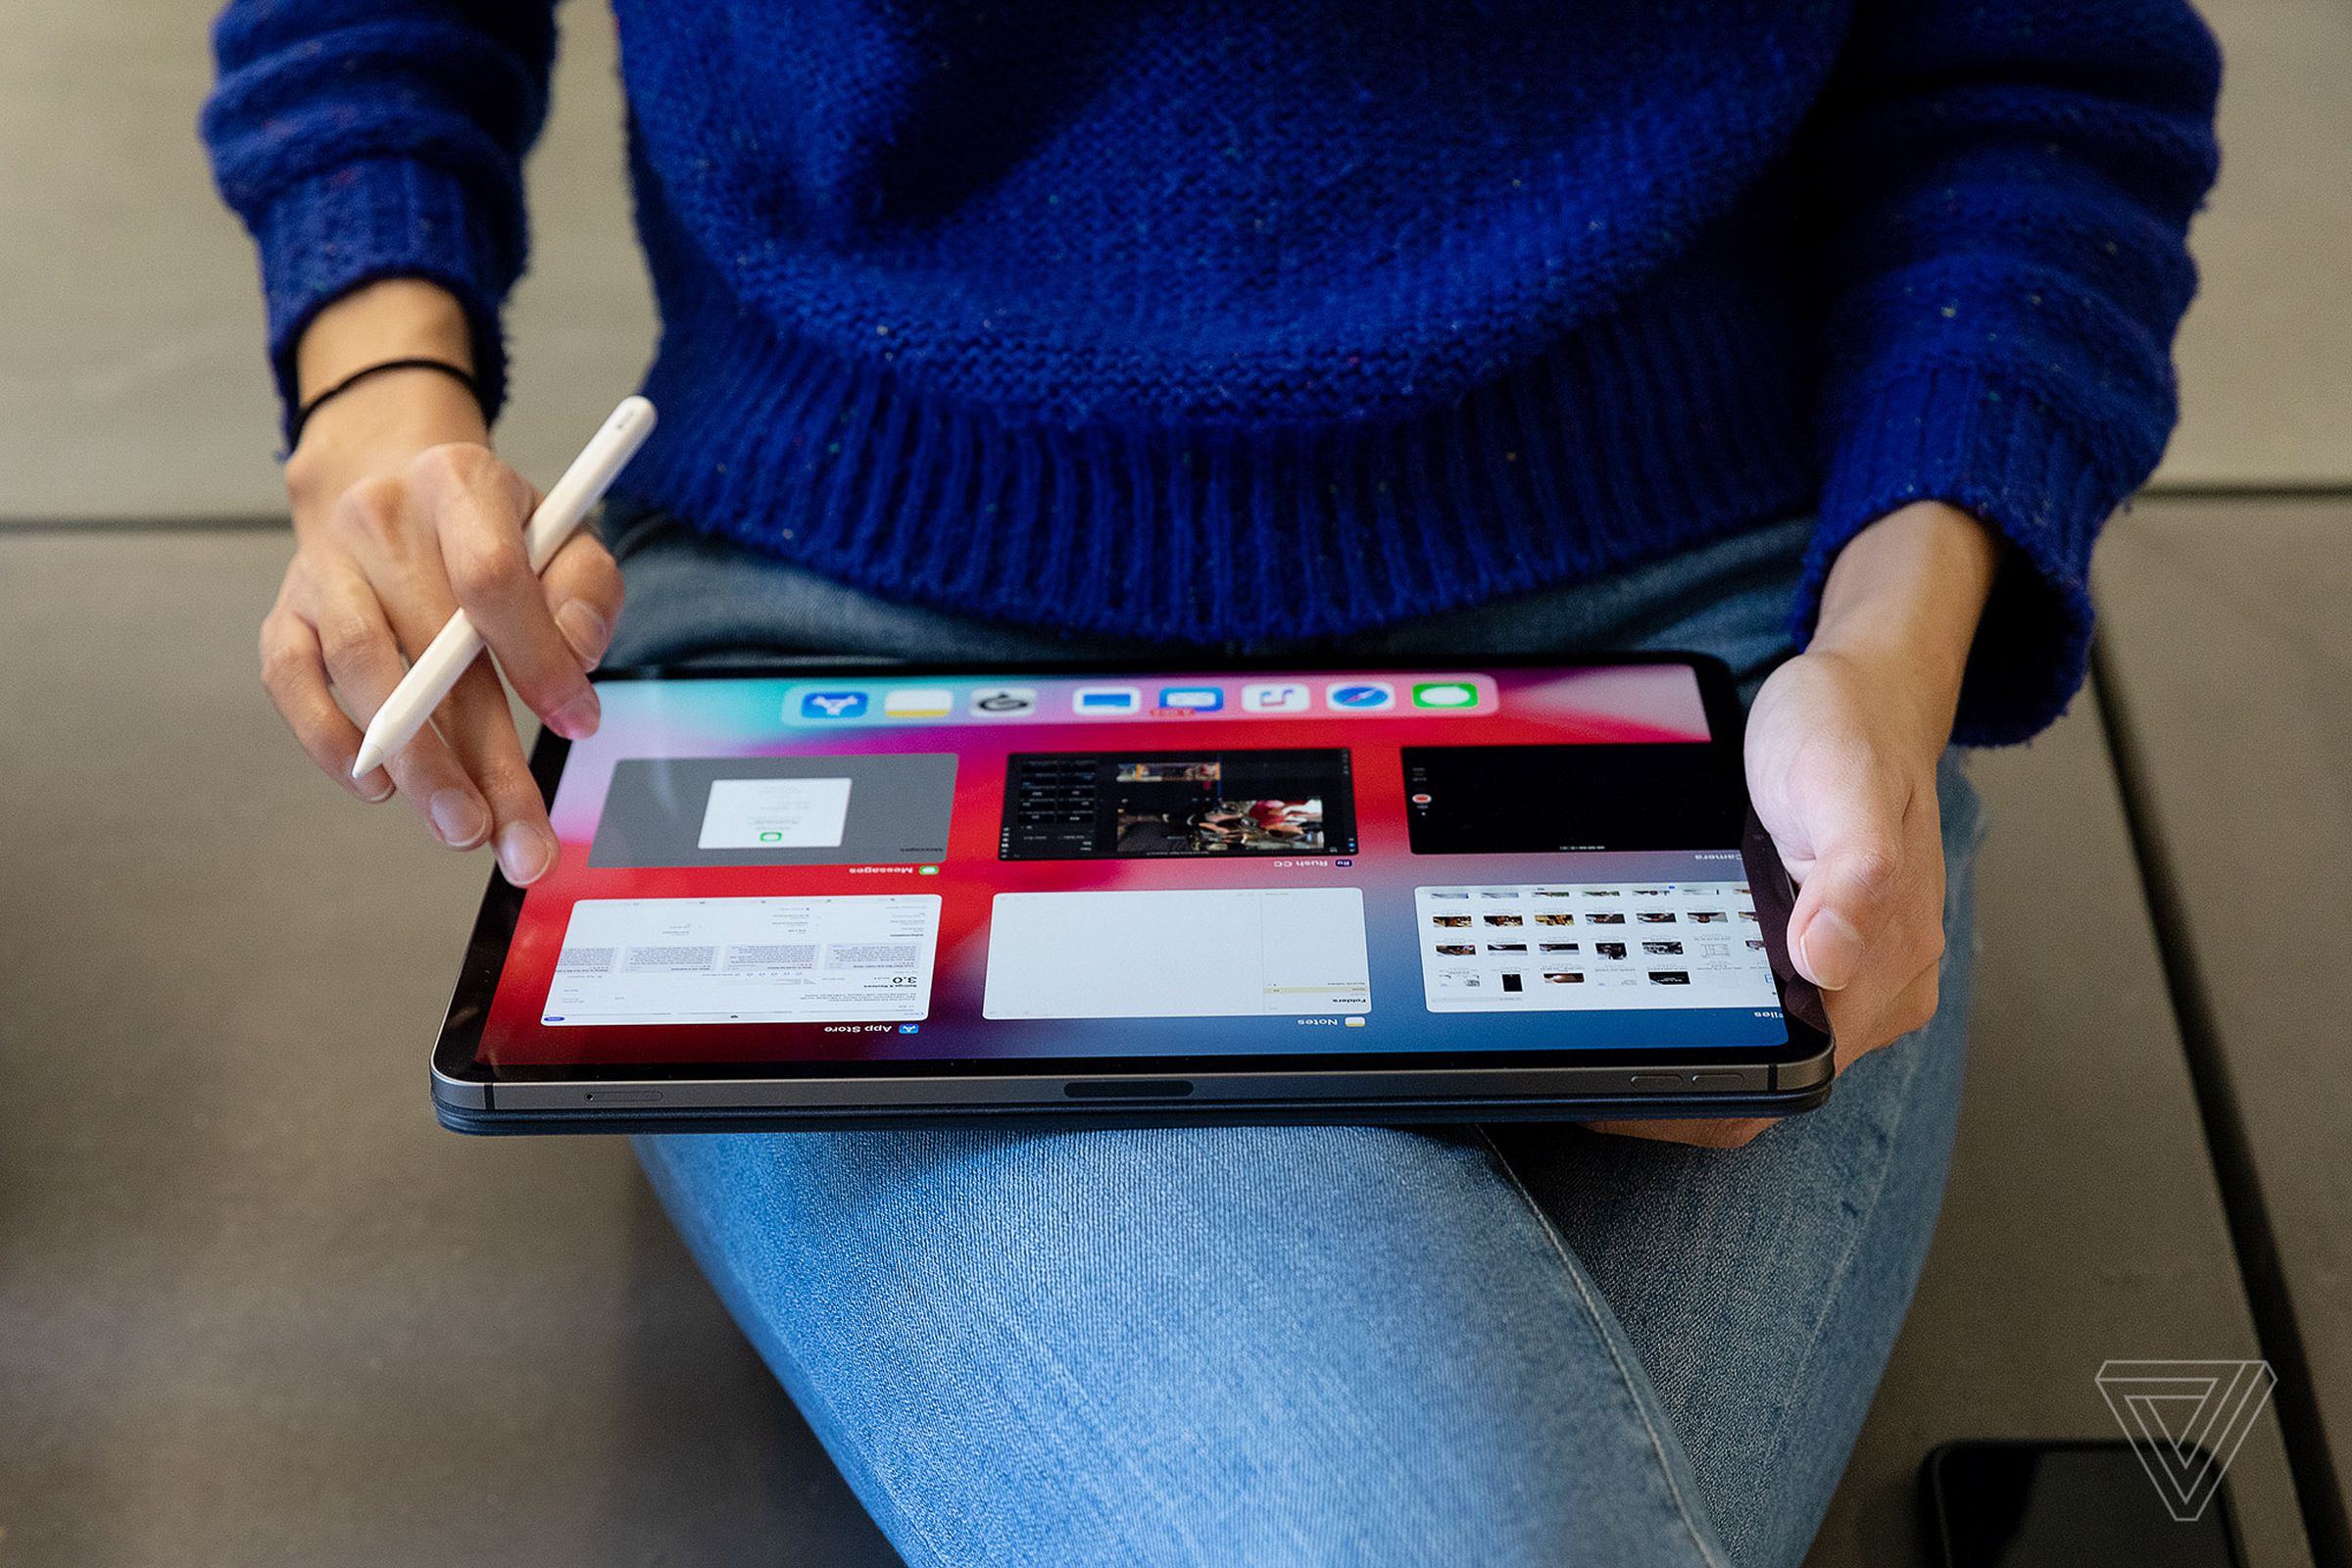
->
[998, 750, 1354, 860]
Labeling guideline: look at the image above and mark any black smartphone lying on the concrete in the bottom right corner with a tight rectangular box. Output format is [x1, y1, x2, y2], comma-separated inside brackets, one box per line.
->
[1919, 1441, 2246, 1568]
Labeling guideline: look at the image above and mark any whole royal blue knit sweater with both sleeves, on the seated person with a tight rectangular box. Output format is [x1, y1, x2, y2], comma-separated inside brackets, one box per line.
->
[205, 0, 2218, 741]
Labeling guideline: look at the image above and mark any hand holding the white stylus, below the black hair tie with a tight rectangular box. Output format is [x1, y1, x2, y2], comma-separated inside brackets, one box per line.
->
[261, 369, 621, 886]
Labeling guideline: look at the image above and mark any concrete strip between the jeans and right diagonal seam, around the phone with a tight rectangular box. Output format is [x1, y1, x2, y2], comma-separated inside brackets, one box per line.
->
[1809, 658, 2310, 1568]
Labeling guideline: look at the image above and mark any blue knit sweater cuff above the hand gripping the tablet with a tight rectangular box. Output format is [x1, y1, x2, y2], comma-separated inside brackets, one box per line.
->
[1792, 369, 2129, 745]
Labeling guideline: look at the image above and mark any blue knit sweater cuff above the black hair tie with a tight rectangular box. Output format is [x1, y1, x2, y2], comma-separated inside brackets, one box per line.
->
[254, 158, 519, 439]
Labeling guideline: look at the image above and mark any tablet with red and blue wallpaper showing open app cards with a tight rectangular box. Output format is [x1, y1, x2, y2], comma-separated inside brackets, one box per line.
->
[433, 656, 1830, 1131]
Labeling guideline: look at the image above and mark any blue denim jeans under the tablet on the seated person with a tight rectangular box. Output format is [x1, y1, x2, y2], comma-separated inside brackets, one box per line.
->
[610, 514, 1978, 1568]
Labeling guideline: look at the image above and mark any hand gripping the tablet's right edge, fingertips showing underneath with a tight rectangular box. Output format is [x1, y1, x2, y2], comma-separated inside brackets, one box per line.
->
[1599, 503, 1997, 1148]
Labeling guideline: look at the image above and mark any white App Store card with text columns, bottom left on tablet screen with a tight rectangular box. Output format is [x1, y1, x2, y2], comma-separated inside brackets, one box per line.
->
[541, 894, 939, 1027]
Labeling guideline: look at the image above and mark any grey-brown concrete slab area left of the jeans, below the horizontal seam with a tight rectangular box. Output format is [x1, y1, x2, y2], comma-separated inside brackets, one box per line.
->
[0, 531, 892, 1568]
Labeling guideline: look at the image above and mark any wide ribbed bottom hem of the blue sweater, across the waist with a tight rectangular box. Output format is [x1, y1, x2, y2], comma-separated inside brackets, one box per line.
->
[618, 278, 1818, 644]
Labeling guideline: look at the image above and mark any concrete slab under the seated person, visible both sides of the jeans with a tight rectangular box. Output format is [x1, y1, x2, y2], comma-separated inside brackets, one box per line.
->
[0, 529, 2310, 1568]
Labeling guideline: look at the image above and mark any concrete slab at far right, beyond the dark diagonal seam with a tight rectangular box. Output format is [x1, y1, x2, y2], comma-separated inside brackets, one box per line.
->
[2095, 489, 2352, 1561]
